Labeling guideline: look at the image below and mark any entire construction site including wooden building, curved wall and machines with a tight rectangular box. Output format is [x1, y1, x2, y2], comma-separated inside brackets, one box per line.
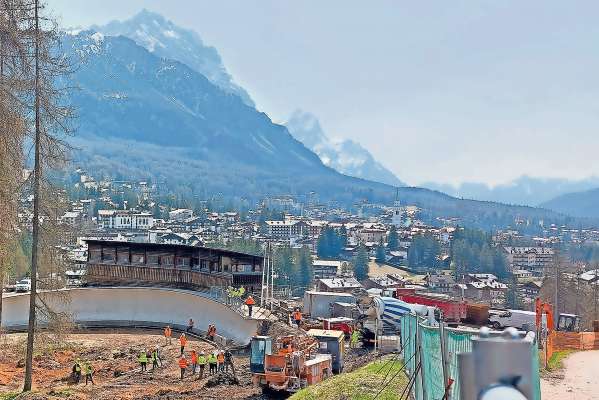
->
[0, 242, 599, 400]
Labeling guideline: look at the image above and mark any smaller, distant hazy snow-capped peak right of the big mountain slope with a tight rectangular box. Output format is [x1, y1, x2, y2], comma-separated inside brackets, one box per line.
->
[285, 110, 404, 186]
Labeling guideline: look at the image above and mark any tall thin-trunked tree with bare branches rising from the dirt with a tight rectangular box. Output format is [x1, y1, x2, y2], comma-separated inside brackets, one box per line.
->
[0, 0, 72, 391]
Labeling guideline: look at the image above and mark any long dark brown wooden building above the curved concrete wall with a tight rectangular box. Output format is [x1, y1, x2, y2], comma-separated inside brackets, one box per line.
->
[86, 240, 264, 291]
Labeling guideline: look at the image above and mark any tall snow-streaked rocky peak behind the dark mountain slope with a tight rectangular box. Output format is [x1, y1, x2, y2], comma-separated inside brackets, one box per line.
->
[90, 9, 254, 107]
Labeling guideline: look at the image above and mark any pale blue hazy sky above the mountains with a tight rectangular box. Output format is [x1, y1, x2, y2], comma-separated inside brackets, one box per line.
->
[48, 0, 599, 184]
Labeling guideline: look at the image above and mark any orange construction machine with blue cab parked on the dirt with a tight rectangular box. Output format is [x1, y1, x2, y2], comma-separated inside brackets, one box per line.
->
[250, 336, 333, 393]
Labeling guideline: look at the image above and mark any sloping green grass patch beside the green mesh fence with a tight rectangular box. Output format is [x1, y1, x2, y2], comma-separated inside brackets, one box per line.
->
[290, 360, 408, 400]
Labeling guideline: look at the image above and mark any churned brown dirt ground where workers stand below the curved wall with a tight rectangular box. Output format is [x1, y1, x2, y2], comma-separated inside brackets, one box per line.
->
[0, 330, 262, 400]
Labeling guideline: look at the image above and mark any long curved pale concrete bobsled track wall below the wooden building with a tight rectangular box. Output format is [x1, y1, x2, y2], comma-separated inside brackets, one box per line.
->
[2, 287, 257, 344]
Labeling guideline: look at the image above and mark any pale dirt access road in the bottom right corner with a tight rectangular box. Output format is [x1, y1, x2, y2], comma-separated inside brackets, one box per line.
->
[541, 350, 599, 400]
